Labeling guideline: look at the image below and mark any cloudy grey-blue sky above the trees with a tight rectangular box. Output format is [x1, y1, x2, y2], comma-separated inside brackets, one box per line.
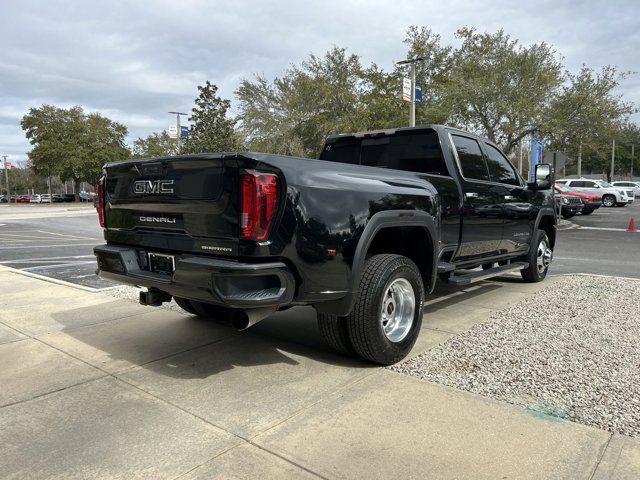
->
[0, 0, 640, 165]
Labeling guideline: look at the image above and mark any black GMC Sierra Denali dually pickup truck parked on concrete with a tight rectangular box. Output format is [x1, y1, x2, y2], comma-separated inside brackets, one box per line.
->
[95, 125, 556, 364]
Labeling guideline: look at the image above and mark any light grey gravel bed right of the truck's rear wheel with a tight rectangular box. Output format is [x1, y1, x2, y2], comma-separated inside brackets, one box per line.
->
[389, 276, 640, 437]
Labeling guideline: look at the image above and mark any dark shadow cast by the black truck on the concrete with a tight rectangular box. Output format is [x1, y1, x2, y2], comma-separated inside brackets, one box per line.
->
[53, 282, 501, 379]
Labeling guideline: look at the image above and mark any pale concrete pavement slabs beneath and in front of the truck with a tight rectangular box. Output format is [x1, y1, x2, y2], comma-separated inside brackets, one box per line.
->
[0, 266, 640, 480]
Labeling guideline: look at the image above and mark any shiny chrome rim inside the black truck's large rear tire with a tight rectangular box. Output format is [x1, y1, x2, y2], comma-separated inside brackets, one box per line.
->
[381, 278, 416, 343]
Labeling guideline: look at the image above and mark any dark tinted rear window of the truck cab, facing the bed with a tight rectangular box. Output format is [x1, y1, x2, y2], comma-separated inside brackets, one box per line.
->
[320, 131, 449, 175]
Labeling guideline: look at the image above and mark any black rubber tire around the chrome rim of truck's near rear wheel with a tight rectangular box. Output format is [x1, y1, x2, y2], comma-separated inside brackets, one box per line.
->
[347, 254, 424, 365]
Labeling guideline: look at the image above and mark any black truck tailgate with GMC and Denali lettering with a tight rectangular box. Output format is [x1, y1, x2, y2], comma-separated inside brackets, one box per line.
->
[105, 156, 239, 254]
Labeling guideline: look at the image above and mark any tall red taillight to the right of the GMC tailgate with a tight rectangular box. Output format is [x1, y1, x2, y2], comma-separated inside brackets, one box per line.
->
[240, 171, 278, 240]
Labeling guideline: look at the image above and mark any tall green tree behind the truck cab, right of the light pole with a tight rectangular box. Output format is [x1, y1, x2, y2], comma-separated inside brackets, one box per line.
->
[442, 28, 563, 154]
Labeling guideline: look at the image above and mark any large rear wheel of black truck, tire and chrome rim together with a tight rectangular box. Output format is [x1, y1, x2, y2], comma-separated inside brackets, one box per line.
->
[346, 254, 424, 365]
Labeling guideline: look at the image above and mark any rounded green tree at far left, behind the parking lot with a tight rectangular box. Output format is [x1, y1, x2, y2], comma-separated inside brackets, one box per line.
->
[21, 105, 129, 189]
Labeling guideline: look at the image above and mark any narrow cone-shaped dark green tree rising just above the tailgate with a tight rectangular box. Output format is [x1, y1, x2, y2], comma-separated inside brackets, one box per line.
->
[183, 80, 242, 153]
